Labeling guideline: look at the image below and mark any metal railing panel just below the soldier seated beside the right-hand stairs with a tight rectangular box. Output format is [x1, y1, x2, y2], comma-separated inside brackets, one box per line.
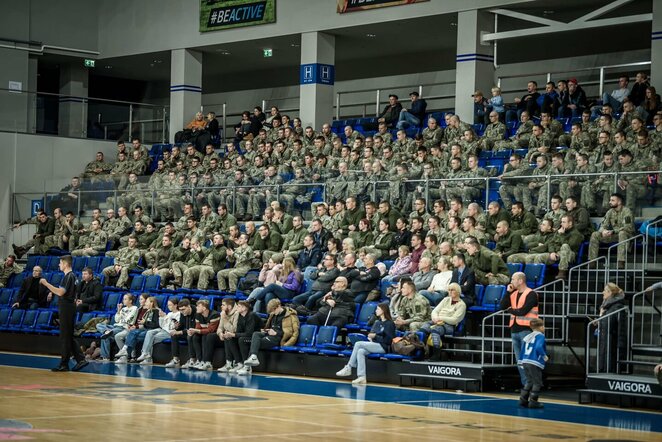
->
[607, 235, 646, 293]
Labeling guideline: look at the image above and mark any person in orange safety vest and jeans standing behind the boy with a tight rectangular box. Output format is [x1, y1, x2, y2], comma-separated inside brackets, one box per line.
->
[501, 272, 538, 386]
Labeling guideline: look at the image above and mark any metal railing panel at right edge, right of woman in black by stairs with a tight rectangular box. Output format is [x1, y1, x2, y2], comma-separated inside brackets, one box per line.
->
[630, 290, 662, 348]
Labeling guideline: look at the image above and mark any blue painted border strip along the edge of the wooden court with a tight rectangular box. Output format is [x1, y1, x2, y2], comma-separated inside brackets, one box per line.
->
[0, 353, 662, 433]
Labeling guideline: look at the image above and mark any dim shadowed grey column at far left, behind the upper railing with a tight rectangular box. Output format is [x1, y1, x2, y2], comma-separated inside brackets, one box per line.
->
[58, 61, 89, 138]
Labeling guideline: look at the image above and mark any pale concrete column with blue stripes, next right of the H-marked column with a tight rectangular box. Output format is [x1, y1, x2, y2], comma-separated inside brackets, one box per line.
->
[455, 10, 494, 123]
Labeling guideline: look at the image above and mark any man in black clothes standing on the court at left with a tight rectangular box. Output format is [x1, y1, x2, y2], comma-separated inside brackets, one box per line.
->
[39, 255, 88, 371]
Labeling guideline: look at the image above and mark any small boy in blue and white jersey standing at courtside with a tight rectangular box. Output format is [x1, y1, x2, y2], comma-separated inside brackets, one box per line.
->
[519, 318, 549, 408]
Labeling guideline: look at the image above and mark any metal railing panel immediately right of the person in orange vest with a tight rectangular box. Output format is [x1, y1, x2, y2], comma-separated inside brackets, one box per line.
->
[535, 279, 566, 342]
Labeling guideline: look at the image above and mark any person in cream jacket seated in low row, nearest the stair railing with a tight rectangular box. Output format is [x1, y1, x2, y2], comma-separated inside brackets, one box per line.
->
[421, 283, 467, 359]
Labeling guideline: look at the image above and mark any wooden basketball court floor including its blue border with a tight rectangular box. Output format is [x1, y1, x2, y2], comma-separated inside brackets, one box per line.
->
[0, 353, 662, 442]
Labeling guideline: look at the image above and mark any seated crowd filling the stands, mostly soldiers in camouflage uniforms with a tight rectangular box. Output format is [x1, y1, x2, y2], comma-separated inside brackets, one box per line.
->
[5, 79, 662, 397]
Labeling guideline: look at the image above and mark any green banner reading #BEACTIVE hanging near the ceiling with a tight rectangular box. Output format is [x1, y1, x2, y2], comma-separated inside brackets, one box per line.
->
[200, 0, 276, 32]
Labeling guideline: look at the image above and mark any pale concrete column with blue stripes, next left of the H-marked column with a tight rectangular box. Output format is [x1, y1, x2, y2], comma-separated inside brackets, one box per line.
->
[170, 49, 202, 142]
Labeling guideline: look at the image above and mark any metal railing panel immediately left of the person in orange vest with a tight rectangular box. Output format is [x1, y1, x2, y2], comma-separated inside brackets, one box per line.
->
[480, 310, 515, 366]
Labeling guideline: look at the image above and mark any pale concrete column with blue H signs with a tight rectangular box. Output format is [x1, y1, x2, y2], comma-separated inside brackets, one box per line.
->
[299, 32, 336, 130]
